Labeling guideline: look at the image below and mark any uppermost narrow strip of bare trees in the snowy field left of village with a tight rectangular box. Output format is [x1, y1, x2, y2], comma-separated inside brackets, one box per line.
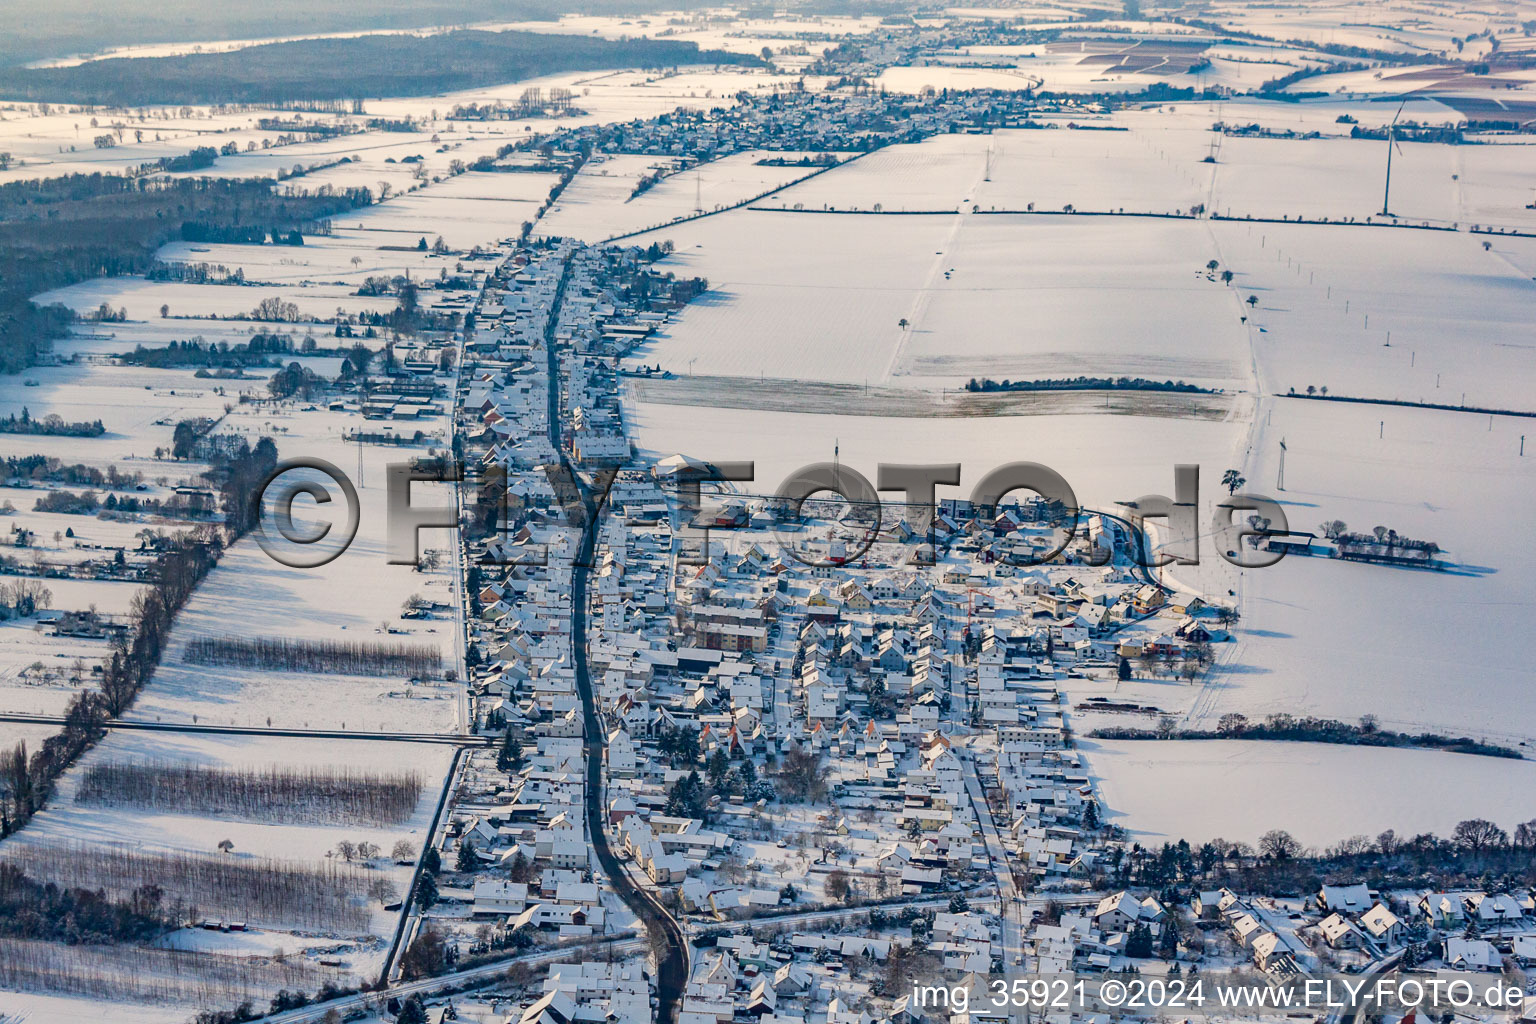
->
[181, 637, 442, 676]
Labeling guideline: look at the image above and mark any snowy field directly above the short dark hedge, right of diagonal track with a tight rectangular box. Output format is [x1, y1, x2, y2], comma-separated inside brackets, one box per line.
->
[892, 215, 1249, 388]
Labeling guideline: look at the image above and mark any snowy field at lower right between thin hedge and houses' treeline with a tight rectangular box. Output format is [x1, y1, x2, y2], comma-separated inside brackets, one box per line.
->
[1078, 740, 1536, 849]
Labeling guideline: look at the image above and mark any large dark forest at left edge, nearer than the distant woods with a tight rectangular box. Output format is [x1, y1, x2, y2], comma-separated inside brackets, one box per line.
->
[0, 173, 373, 373]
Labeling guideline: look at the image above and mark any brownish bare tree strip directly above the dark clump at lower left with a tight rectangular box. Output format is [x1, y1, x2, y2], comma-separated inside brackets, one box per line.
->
[0, 841, 373, 935]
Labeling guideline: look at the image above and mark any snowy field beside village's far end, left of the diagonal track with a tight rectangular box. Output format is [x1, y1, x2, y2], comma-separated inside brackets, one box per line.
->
[620, 208, 955, 384]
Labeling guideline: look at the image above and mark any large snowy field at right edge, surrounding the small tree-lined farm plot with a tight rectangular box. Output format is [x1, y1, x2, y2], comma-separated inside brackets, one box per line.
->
[1167, 398, 1536, 746]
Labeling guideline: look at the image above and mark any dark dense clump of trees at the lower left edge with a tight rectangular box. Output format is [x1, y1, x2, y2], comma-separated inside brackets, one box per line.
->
[0, 863, 168, 946]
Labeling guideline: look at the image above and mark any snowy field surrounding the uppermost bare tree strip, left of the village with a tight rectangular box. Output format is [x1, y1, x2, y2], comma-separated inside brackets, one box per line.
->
[129, 408, 461, 732]
